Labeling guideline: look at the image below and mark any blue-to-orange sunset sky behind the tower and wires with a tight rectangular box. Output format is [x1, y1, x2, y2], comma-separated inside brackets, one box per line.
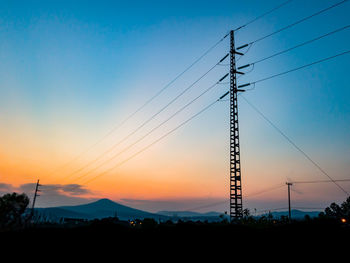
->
[0, 0, 350, 212]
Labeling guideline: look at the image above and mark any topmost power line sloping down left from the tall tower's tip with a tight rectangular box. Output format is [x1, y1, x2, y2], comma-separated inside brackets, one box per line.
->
[49, 33, 229, 182]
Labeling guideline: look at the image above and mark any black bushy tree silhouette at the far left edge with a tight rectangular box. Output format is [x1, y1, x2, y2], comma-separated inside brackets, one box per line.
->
[0, 193, 29, 230]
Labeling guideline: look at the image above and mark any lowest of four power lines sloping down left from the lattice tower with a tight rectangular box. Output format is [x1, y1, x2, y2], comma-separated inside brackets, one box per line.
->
[84, 92, 228, 187]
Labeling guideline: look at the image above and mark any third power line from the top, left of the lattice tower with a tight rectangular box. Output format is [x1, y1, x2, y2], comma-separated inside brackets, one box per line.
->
[69, 73, 229, 186]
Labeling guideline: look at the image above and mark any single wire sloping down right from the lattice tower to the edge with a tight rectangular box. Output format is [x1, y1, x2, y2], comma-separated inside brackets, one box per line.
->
[241, 95, 349, 195]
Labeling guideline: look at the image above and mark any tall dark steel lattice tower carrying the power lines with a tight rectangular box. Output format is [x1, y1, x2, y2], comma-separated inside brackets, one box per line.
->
[230, 30, 246, 222]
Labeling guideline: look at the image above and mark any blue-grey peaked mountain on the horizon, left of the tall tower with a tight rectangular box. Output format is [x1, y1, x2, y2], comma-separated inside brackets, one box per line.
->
[36, 199, 165, 220]
